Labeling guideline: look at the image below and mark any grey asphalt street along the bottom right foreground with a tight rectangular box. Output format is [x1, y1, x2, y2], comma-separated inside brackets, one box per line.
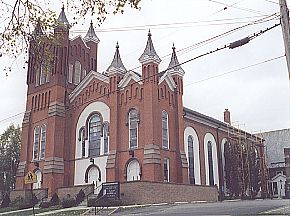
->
[113, 199, 290, 216]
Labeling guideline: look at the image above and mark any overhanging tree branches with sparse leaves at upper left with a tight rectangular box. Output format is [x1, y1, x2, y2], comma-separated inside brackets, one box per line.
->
[0, 0, 141, 69]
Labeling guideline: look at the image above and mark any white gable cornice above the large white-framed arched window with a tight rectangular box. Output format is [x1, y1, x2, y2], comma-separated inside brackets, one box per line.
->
[69, 70, 109, 101]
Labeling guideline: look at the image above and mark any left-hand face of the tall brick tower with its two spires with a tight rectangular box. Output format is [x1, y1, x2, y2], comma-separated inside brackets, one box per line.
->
[16, 7, 70, 196]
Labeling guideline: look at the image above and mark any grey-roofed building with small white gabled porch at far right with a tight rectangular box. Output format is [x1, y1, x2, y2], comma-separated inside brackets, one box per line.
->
[262, 129, 290, 197]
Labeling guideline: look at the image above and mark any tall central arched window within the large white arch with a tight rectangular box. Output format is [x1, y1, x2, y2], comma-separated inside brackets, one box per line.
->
[89, 114, 102, 157]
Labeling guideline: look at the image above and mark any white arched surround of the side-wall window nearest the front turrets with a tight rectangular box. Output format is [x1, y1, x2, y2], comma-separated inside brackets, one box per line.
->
[184, 127, 201, 185]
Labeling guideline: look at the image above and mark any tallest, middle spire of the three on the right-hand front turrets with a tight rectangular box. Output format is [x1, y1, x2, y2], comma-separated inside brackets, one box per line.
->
[139, 30, 161, 64]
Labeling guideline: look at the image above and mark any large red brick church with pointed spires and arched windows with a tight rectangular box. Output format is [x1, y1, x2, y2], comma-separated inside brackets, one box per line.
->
[16, 6, 263, 199]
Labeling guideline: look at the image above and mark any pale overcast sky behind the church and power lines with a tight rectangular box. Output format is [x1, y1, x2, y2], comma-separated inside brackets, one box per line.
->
[0, 0, 290, 133]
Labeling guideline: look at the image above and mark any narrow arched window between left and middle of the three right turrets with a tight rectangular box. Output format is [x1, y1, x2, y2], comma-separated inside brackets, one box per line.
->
[129, 109, 138, 148]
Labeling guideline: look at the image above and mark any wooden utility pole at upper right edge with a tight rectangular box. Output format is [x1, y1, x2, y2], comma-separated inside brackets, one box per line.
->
[279, 0, 290, 80]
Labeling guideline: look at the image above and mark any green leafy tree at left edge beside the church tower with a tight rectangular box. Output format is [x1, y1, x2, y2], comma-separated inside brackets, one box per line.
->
[0, 125, 21, 192]
